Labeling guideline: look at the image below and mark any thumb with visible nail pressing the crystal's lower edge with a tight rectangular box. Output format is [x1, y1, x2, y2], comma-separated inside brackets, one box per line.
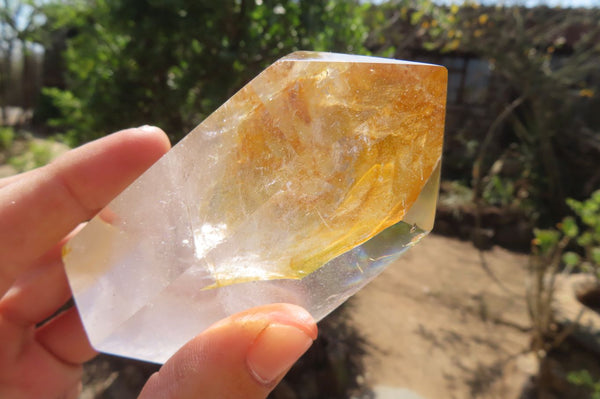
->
[139, 304, 317, 399]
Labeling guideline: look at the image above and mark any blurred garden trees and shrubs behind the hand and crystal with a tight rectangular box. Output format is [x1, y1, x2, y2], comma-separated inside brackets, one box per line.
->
[0, 0, 600, 398]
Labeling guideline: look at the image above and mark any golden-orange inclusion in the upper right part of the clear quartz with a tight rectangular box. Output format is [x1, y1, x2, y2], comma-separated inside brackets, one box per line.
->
[192, 52, 447, 286]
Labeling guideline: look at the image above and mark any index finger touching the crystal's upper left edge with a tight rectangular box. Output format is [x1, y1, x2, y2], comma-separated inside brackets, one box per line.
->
[0, 127, 170, 297]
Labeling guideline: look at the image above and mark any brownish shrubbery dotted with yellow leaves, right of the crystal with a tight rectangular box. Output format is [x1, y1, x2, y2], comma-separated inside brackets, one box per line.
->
[368, 0, 600, 220]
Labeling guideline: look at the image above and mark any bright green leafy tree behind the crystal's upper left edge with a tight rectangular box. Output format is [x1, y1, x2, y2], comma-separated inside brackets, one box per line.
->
[39, 0, 367, 141]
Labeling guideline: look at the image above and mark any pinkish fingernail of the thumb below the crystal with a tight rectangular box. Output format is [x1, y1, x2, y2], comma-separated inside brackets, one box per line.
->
[246, 324, 313, 385]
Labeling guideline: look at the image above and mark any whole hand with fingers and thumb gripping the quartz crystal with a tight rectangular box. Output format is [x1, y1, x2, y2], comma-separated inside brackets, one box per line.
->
[0, 127, 317, 399]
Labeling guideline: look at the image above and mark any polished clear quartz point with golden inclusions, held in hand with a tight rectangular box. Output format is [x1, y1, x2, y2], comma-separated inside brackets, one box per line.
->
[63, 52, 447, 363]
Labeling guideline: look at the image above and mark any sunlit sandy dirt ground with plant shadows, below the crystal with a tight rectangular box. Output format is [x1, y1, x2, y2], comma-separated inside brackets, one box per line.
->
[351, 235, 536, 399]
